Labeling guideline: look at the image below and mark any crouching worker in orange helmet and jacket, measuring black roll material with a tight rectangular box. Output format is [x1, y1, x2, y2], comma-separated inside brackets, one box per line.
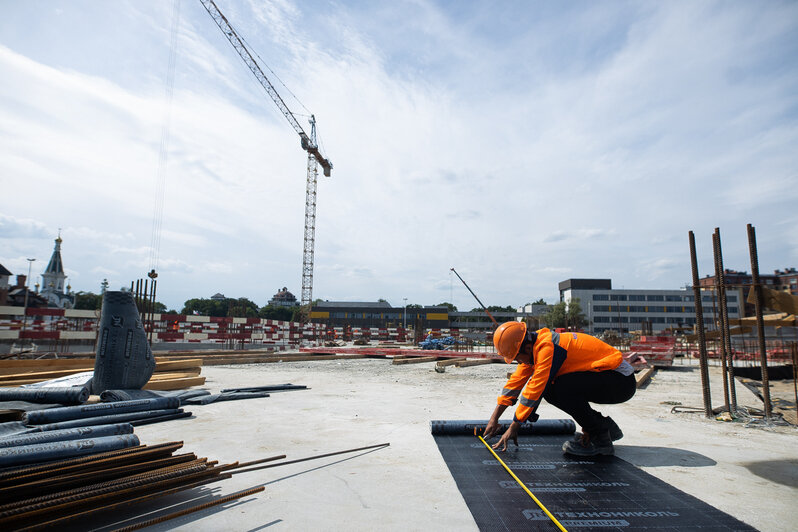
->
[484, 321, 637, 456]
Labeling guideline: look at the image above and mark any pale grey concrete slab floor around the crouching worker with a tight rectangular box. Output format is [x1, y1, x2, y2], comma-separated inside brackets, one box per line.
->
[114, 359, 798, 531]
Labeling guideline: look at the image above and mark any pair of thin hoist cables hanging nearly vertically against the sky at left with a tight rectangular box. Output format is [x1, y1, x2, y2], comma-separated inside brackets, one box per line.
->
[150, 0, 180, 273]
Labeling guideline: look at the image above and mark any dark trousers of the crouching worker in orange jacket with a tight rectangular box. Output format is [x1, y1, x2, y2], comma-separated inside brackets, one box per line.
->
[543, 370, 637, 433]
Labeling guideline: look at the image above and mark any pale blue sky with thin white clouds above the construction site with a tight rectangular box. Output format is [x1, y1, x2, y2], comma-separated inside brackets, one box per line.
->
[0, 0, 798, 311]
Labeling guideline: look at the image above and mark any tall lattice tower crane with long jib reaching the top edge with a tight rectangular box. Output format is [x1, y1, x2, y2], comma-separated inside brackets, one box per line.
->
[199, 0, 332, 315]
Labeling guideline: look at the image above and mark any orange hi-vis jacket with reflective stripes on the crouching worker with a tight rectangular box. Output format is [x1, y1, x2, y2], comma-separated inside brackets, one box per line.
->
[498, 328, 623, 423]
